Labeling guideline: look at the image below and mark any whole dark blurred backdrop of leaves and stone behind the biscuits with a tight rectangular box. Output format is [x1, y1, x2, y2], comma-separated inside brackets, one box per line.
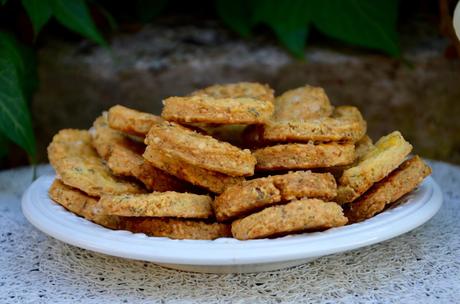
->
[0, 0, 460, 168]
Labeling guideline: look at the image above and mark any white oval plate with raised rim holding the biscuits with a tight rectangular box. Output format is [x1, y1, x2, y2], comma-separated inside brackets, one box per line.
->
[22, 176, 442, 273]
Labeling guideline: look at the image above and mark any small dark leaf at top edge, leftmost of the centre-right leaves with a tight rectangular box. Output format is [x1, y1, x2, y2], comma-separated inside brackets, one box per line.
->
[215, 0, 252, 38]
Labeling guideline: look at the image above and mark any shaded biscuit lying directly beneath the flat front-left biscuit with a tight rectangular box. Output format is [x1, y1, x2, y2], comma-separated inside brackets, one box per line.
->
[120, 217, 232, 240]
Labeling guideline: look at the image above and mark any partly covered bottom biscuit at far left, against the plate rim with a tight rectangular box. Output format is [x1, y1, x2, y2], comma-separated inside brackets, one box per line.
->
[48, 179, 118, 229]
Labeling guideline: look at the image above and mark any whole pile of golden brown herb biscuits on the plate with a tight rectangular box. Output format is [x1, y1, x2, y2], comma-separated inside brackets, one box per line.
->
[48, 83, 431, 240]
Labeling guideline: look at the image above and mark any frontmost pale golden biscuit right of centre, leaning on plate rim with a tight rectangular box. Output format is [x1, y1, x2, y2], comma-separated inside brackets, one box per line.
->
[232, 199, 347, 240]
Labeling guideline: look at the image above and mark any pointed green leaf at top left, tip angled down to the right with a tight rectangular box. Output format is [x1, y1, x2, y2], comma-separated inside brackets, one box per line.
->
[49, 0, 107, 45]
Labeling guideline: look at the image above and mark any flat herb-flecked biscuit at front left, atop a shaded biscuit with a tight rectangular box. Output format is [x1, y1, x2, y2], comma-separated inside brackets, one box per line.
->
[99, 191, 213, 219]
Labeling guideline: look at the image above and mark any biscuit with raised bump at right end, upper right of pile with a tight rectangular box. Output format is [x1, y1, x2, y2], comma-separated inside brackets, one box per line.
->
[263, 106, 366, 142]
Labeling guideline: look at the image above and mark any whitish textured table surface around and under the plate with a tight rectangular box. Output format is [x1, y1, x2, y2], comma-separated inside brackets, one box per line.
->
[0, 162, 460, 304]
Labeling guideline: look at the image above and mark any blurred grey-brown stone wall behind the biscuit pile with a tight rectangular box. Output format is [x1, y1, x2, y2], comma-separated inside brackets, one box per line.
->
[32, 24, 460, 163]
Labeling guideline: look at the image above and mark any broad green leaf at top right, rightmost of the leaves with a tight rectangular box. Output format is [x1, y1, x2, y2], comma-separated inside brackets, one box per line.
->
[310, 0, 400, 56]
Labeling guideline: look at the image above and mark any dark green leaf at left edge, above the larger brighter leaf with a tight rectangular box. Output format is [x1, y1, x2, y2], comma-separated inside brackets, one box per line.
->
[0, 32, 38, 101]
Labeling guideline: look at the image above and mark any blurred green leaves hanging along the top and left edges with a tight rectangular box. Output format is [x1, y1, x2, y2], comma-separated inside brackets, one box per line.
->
[0, 0, 399, 161]
